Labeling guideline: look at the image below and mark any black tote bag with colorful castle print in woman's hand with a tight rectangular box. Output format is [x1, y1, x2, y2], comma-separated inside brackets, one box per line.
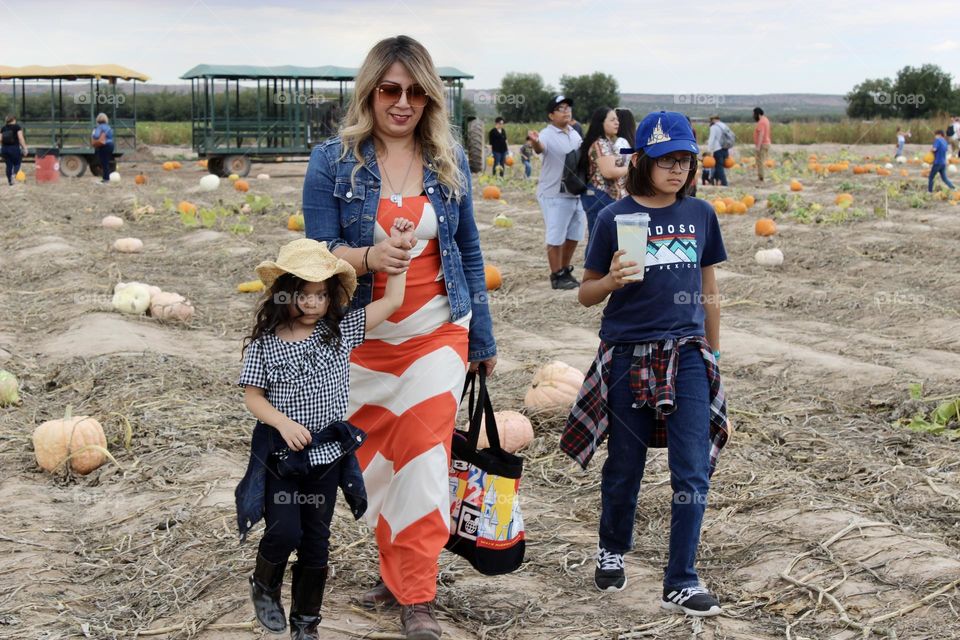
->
[446, 367, 526, 576]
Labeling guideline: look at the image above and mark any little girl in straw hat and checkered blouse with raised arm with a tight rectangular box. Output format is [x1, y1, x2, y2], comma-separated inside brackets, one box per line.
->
[236, 226, 413, 640]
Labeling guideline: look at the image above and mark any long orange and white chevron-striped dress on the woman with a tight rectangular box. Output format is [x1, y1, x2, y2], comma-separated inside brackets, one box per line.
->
[347, 196, 470, 604]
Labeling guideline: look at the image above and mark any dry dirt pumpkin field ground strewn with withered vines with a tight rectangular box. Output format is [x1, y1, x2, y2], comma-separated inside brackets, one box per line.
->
[0, 145, 960, 640]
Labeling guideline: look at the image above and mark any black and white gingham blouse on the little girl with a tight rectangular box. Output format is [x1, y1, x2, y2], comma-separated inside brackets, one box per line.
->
[237, 308, 366, 465]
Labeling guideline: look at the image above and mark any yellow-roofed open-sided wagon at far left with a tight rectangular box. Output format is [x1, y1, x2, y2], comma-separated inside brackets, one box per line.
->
[0, 64, 150, 178]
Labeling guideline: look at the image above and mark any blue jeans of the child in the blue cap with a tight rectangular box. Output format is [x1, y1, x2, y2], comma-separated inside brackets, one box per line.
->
[600, 345, 711, 588]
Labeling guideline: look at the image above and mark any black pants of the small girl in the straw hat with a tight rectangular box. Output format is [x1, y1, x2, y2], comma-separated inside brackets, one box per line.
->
[260, 456, 340, 567]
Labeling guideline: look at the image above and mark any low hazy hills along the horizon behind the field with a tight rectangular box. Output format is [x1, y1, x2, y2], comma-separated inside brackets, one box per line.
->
[463, 89, 847, 122]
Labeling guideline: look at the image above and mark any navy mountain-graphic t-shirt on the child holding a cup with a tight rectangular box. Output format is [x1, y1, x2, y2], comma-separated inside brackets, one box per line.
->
[584, 196, 727, 343]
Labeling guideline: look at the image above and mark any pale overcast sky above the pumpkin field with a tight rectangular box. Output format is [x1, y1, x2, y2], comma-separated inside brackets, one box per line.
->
[0, 0, 960, 94]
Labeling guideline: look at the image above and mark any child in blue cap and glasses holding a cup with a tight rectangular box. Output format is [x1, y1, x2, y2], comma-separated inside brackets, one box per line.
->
[561, 111, 728, 616]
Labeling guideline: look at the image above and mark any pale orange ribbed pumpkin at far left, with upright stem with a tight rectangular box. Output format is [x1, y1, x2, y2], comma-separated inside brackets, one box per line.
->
[33, 407, 107, 475]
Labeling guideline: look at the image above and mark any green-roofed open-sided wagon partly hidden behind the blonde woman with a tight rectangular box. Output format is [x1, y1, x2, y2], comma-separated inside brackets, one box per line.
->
[181, 64, 473, 176]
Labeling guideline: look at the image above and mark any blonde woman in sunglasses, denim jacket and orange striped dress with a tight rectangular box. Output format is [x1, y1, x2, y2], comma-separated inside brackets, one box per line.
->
[303, 36, 497, 640]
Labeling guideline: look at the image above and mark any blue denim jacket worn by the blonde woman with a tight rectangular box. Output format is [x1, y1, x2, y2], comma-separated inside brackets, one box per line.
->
[303, 137, 497, 362]
